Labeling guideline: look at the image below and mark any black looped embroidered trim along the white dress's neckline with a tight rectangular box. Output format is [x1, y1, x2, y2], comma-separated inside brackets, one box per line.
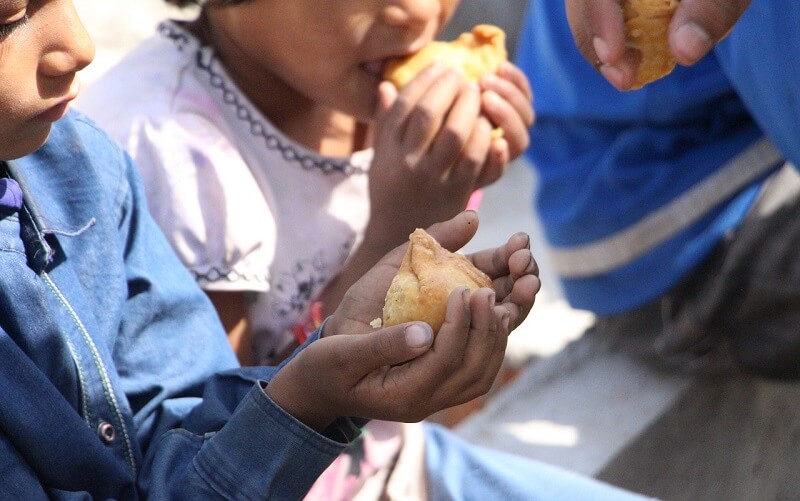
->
[158, 22, 366, 176]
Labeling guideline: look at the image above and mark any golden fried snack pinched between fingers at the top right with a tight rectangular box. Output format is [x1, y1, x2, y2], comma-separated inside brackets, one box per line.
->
[622, 0, 680, 89]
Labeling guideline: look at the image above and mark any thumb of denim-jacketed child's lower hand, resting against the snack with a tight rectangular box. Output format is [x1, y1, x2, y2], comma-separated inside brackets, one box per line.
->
[353, 322, 433, 373]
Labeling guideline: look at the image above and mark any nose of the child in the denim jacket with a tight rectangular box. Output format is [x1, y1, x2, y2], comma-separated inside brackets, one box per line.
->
[41, 2, 95, 76]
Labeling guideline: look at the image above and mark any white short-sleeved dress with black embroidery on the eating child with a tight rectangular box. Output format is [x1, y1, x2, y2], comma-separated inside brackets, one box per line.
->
[77, 22, 372, 362]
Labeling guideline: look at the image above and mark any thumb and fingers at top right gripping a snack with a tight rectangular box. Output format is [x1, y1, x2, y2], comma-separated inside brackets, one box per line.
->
[565, 0, 750, 90]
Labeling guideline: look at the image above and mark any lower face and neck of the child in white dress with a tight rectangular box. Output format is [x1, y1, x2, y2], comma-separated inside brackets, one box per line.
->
[196, 0, 458, 155]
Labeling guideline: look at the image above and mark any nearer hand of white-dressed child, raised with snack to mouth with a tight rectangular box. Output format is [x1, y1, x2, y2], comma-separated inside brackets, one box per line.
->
[365, 65, 492, 233]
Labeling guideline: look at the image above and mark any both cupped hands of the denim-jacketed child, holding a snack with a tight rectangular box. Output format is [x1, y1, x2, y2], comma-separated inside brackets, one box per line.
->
[266, 211, 540, 430]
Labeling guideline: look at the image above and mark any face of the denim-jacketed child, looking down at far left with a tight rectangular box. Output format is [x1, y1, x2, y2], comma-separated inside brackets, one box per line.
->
[0, 0, 94, 160]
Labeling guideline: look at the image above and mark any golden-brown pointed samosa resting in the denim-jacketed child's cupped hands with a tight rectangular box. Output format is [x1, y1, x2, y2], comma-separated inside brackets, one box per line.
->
[382, 229, 492, 334]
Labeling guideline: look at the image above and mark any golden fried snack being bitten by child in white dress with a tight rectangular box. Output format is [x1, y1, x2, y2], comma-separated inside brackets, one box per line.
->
[383, 24, 508, 89]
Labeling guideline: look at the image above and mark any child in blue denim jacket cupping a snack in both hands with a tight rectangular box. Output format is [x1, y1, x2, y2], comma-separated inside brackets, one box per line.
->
[0, 0, 648, 499]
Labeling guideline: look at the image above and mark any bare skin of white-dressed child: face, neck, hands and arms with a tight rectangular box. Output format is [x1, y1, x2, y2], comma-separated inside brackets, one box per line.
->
[190, 0, 533, 361]
